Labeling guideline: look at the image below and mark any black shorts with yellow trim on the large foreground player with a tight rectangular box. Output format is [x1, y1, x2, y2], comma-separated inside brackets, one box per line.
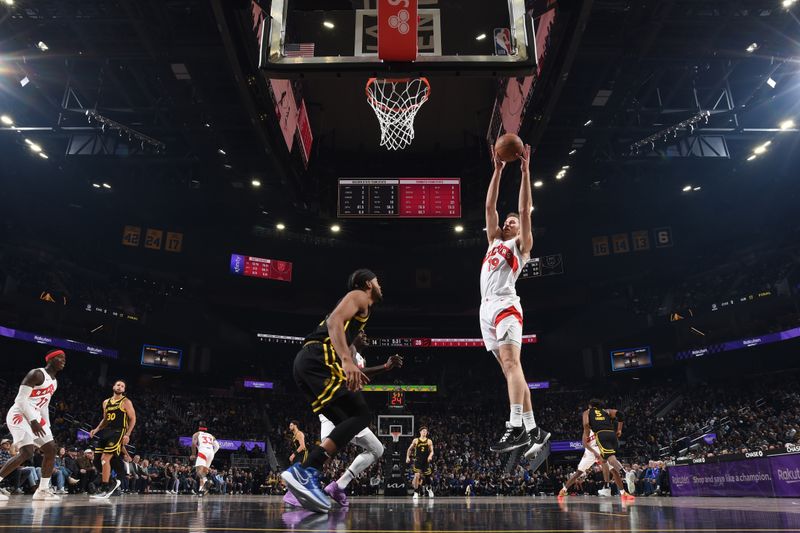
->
[294, 341, 349, 413]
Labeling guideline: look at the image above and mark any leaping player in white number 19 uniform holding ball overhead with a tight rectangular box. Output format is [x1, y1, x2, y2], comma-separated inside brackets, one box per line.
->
[480, 145, 550, 457]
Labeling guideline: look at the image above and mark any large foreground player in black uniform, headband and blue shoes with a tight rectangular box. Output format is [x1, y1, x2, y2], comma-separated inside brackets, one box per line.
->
[281, 269, 383, 512]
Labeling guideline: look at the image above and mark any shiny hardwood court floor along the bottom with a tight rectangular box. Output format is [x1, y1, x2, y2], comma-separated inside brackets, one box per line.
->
[0, 495, 800, 533]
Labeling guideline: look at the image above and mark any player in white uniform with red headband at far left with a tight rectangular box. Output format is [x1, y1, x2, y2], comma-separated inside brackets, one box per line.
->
[0, 350, 67, 501]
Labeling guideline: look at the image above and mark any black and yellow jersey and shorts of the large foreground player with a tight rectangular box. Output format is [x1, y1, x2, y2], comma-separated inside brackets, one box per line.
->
[294, 308, 369, 413]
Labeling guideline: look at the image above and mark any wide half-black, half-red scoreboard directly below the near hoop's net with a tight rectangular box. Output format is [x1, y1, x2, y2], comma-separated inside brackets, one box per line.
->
[338, 178, 461, 218]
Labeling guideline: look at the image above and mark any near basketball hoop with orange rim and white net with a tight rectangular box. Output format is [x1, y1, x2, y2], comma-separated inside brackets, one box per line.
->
[366, 78, 431, 150]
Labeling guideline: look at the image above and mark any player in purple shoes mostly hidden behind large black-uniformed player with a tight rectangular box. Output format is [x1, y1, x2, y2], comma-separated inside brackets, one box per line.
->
[283, 330, 403, 507]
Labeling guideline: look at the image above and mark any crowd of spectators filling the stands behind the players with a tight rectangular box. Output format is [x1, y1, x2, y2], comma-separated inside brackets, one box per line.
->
[0, 362, 800, 496]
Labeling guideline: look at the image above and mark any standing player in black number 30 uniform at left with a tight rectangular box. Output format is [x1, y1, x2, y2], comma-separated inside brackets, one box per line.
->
[89, 379, 136, 499]
